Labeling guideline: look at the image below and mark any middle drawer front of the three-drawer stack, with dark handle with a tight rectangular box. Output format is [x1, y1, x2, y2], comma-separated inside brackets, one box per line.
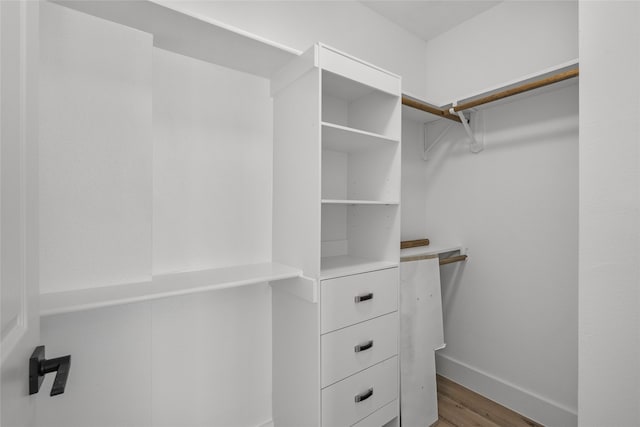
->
[321, 312, 398, 387]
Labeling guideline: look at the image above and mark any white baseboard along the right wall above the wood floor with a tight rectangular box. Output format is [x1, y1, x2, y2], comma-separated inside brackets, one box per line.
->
[436, 354, 578, 427]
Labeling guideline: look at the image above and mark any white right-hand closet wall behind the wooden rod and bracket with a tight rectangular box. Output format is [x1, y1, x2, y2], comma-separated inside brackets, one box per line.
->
[412, 1, 578, 426]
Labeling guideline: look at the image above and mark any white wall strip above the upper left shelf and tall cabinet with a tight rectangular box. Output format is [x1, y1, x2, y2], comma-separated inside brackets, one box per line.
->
[156, 0, 428, 97]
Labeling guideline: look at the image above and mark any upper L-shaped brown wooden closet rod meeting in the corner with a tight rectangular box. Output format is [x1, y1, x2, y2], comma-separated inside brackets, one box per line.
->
[402, 67, 580, 123]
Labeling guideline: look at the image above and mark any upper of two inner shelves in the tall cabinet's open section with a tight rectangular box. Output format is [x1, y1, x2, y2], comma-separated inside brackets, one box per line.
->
[322, 122, 400, 153]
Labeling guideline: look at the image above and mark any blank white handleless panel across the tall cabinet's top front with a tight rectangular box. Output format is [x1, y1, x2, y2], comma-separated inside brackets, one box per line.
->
[319, 46, 401, 96]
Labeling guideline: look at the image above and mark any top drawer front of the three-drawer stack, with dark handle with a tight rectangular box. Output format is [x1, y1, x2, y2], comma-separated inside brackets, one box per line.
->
[320, 268, 399, 334]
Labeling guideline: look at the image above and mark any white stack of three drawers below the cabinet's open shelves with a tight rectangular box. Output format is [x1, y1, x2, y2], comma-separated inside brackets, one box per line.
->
[320, 267, 399, 427]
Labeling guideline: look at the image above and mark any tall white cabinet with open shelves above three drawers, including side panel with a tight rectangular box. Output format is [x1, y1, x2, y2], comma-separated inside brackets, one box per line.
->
[272, 44, 401, 427]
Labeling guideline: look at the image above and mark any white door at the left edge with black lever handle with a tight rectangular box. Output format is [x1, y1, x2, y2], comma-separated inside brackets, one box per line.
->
[0, 0, 40, 427]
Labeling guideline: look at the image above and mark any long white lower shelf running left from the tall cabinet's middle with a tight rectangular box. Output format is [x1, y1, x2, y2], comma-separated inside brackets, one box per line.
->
[40, 263, 302, 316]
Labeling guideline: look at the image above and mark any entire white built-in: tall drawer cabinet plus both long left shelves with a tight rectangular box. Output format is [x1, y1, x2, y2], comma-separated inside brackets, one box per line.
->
[41, 1, 401, 427]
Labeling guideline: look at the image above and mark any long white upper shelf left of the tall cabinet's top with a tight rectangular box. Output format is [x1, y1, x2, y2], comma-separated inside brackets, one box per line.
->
[54, 0, 300, 78]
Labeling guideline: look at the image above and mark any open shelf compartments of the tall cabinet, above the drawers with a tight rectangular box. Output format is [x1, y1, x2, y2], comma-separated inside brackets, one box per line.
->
[320, 50, 401, 277]
